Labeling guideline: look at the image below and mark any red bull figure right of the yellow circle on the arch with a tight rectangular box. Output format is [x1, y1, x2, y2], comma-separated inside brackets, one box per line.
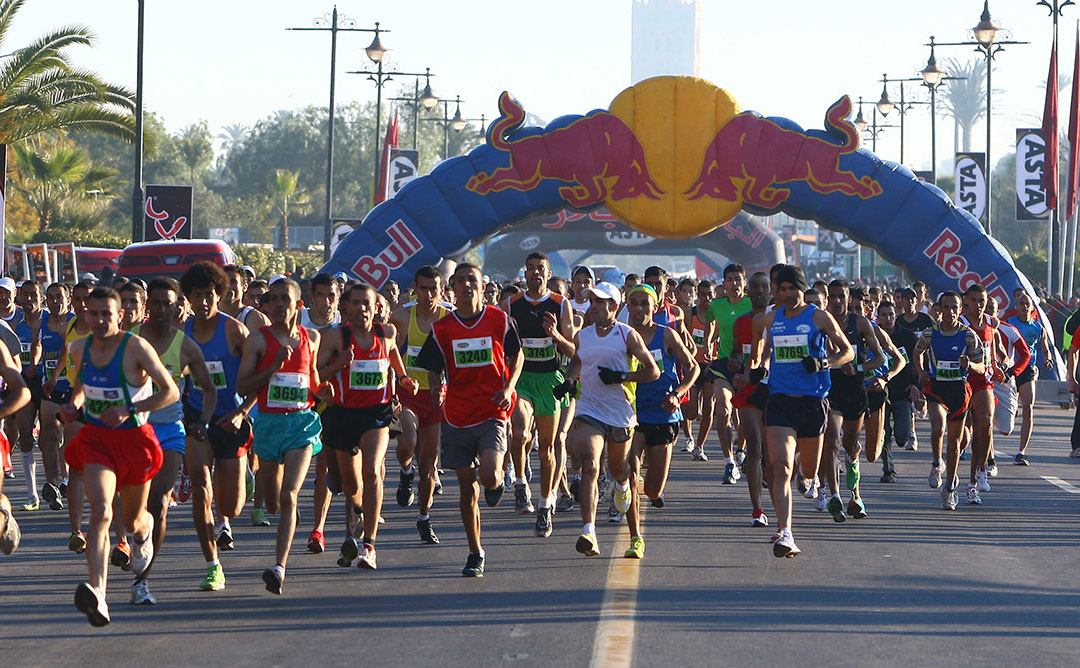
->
[684, 96, 881, 209]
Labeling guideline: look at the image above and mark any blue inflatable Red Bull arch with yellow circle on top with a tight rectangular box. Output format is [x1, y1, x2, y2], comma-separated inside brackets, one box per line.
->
[323, 77, 1030, 319]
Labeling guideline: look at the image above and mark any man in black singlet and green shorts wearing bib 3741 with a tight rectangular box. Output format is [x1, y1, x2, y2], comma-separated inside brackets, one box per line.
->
[503, 253, 575, 537]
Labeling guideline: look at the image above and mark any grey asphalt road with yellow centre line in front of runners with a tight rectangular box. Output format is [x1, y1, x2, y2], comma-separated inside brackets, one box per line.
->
[0, 405, 1080, 667]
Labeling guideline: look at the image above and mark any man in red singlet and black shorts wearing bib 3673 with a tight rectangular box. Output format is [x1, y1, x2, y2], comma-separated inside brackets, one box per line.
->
[319, 283, 418, 570]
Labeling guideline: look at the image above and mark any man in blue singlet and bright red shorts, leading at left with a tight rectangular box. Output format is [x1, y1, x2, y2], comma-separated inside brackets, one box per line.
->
[60, 287, 180, 626]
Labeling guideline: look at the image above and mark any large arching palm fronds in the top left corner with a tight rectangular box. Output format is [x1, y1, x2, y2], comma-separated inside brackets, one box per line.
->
[0, 0, 135, 144]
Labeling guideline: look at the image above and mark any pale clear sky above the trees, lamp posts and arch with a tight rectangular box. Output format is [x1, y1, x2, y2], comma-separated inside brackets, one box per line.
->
[10, 0, 1080, 173]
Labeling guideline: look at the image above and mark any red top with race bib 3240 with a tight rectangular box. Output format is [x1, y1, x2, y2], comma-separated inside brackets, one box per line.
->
[431, 305, 513, 428]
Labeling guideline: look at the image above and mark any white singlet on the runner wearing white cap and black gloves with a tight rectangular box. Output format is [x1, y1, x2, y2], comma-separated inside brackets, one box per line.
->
[577, 322, 637, 428]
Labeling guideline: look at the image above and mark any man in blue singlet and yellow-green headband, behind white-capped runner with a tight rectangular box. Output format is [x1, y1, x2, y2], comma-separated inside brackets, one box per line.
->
[622, 285, 701, 559]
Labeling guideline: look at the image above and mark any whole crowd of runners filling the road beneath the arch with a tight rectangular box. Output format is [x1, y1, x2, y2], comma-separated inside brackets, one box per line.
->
[0, 253, 1062, 626]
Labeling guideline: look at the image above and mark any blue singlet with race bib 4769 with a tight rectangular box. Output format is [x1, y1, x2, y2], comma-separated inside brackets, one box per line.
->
[769, 304, 832, 397]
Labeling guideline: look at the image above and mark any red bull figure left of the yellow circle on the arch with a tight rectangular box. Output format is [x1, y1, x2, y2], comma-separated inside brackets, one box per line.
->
[465, 93, 664, 208]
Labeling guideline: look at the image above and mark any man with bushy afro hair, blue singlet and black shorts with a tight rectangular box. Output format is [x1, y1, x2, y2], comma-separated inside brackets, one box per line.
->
[180, 262, 255, 591]
